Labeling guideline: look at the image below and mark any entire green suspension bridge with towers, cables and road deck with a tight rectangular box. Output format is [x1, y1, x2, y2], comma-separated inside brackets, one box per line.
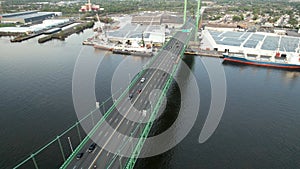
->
[14, 0, 204, 169]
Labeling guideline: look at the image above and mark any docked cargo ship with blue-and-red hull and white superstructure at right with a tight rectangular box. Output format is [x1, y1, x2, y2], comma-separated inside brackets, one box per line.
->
[223, 51, 300, 70]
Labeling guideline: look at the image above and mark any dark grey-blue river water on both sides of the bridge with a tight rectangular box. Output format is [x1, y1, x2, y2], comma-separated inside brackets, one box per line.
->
[0, 30, 300, 169]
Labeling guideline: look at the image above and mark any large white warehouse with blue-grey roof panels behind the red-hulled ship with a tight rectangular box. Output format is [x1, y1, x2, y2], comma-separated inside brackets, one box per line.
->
[201, 29, 300, 56]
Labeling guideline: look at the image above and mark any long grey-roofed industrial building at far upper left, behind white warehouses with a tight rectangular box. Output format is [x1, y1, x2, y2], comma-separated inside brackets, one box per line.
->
[0, 11, 61, 24]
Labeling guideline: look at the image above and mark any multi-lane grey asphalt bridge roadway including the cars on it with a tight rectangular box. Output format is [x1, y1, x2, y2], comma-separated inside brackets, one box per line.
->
[61, 22, 194, 169]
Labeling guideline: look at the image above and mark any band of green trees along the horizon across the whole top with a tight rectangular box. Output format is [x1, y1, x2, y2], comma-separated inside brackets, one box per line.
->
[1, 0, 300, 27]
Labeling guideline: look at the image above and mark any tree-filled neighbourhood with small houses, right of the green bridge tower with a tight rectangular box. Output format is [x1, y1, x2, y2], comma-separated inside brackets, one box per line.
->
[203, 0, 300, 28]
